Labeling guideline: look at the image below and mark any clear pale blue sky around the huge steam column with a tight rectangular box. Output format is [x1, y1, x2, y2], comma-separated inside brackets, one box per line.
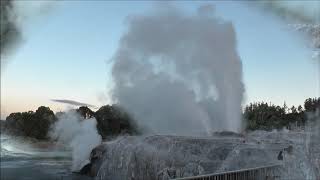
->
[1, 1, 320, 118]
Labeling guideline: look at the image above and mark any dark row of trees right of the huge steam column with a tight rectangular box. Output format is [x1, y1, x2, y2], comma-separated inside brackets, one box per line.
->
[243, 97, 320, 130]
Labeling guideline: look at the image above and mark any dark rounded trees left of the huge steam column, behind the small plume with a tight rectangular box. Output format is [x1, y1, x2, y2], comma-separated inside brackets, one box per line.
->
[1, 105, 139, 140]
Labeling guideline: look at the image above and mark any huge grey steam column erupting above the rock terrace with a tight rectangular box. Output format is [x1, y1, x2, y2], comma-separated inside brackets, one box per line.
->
[112, 5, 244, 135]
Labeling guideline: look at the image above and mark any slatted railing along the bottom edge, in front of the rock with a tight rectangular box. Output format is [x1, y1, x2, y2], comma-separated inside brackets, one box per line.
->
[174, 165, 281, 180]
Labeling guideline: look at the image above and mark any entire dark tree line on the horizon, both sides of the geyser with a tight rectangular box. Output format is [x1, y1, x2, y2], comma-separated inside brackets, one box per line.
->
[1, 98, 320, 139]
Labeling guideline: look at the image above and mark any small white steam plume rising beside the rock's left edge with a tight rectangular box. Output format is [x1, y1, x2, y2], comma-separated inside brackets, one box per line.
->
[50, 111, 102, 172]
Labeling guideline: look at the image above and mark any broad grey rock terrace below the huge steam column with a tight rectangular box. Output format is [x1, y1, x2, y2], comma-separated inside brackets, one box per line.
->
[87, 132, 317, 180]
